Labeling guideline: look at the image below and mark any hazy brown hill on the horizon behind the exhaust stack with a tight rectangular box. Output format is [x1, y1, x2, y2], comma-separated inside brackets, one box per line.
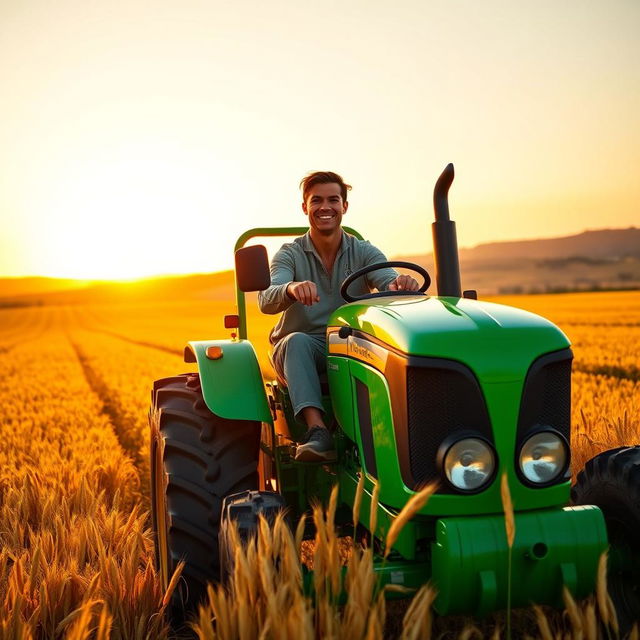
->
[397, 227, 640, 295]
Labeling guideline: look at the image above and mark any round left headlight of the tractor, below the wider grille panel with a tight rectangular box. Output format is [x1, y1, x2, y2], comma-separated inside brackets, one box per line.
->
[443, 438, 496, 491]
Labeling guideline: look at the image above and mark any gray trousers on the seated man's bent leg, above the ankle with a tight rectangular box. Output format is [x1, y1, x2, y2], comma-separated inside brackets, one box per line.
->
[273, 332, 327, 416]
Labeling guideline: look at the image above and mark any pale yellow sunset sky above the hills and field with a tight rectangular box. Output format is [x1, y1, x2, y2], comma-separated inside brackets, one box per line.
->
[0, 0, 640, 279]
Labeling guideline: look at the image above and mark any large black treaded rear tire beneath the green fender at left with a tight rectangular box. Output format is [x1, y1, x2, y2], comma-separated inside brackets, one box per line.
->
[149, 373, 261, 627]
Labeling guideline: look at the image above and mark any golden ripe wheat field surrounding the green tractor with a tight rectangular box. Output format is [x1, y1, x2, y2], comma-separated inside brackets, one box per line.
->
[0, 292, 640, 640]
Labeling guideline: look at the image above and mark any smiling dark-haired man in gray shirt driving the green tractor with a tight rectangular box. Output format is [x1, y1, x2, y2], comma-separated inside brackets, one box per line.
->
[258, 171, 418, 461]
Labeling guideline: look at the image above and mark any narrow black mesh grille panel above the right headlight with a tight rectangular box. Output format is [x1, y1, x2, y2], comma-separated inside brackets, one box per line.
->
[518, 349, 573, 449]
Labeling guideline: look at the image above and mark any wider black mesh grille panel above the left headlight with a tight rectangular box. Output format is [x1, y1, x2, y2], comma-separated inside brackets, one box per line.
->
[403, 358, 493, 493]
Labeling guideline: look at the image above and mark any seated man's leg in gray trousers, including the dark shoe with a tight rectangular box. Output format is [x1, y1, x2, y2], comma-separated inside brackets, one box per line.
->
[273, 333, 335, 460]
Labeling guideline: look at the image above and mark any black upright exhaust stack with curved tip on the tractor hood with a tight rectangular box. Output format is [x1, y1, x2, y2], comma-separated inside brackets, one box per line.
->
[431, 163, 462, 298]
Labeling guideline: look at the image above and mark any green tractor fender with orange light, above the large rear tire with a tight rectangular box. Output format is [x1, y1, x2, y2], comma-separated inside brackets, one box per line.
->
[184, 340, 272, 422]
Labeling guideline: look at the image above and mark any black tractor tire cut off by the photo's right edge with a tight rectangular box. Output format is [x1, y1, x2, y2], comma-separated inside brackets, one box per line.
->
[571, 446, 640, 633]
